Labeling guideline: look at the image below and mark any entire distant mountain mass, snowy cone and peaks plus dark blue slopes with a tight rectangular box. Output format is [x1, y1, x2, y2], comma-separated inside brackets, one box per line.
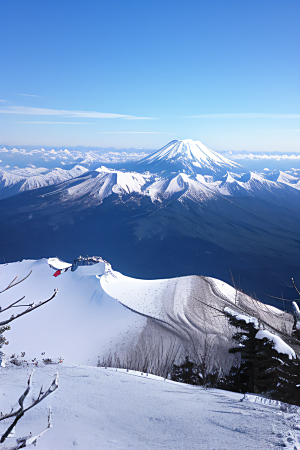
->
[0, 140, 300, 307]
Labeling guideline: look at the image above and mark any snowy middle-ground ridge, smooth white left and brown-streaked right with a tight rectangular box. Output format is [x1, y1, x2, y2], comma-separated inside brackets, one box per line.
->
[0, 258, 293, 369]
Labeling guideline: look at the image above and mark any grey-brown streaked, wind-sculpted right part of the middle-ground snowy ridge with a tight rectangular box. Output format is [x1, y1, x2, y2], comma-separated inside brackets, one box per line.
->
[100, 272, 293, 368]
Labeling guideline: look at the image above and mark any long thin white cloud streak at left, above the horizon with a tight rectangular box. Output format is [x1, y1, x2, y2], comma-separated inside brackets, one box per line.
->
[0, 106, 152, 119]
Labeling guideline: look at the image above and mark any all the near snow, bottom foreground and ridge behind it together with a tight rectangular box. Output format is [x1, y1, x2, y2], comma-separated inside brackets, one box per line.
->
[0, 258, 300, 450]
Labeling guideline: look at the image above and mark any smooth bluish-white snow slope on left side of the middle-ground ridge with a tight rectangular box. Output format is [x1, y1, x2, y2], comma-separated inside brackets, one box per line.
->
[0, 259, 145, 365]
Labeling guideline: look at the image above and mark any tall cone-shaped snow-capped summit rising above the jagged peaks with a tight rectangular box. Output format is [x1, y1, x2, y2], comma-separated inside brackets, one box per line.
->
[137, 139, 241, 174]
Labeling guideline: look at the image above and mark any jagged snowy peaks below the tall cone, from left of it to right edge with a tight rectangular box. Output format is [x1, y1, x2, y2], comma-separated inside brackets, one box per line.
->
[60, 166, 300, 205]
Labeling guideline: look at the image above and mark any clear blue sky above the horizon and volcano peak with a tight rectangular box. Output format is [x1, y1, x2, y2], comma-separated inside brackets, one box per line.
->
[0, 0, 300, 152]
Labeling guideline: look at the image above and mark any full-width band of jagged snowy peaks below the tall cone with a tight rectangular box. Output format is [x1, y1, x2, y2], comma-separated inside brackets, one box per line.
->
[0, 160, 300, 204]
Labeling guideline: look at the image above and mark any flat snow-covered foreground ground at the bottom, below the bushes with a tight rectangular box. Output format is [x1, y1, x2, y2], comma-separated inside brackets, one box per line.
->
[0, 364, 300, 450]
